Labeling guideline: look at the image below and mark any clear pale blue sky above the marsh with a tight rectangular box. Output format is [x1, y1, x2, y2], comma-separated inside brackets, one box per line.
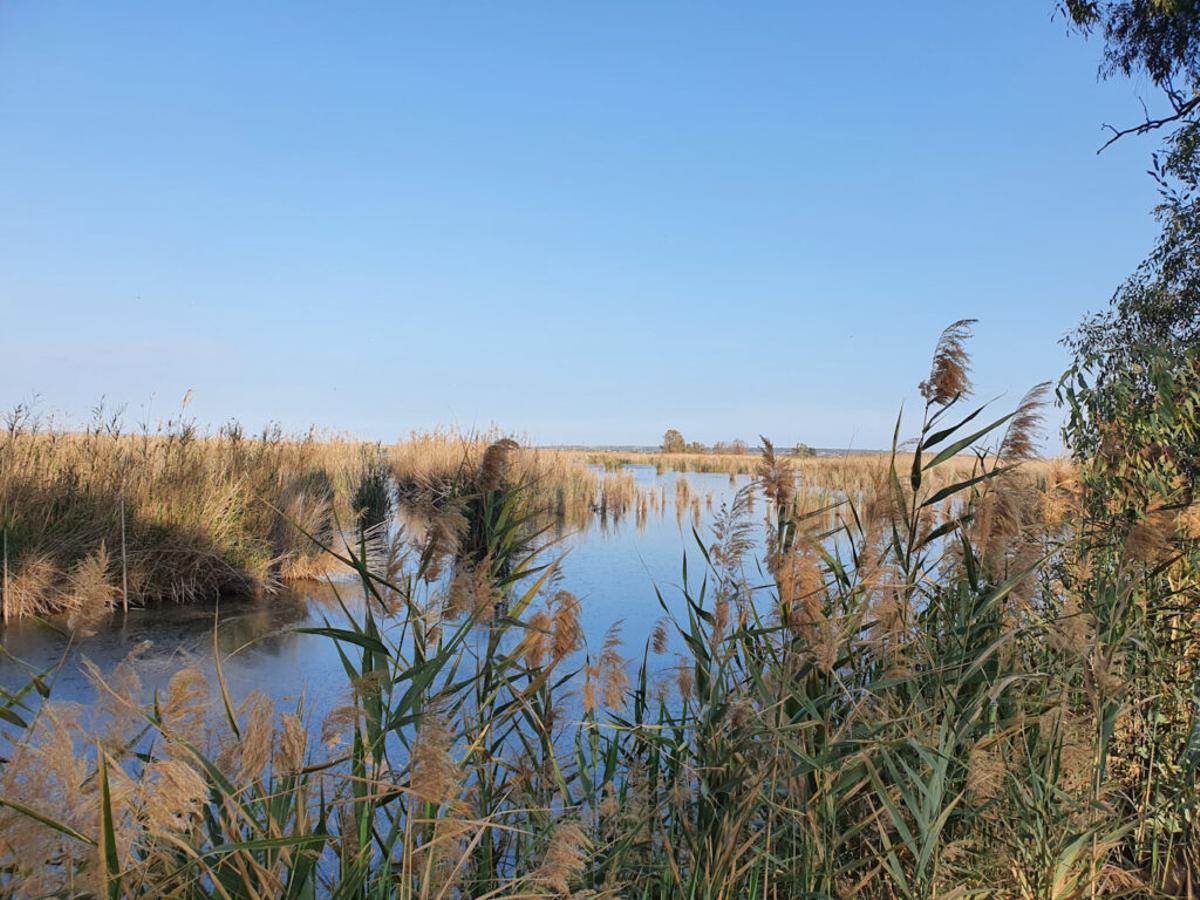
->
[0, 0, 1157, 449]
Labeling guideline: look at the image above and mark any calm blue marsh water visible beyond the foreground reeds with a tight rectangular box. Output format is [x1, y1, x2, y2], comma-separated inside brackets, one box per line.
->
[0, 466, 763, 714]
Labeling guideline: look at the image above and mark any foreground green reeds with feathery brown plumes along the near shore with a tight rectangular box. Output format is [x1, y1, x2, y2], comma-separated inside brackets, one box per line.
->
[0, 323, 1200, 899]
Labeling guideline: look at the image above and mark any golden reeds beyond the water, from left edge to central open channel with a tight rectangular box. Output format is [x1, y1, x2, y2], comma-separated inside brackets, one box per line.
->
[0, 427, 600, 624]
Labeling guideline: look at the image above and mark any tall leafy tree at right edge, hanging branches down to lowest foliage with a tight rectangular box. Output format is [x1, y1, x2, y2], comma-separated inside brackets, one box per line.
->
[1058, 8, 1200, 888]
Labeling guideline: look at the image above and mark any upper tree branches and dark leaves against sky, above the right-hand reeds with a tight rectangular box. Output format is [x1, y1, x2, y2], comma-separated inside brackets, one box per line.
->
[1058, 0, 1200, 492]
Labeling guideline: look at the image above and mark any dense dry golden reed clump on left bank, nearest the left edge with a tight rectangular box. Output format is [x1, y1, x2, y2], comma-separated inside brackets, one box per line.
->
[0, 409, 378, 617]
